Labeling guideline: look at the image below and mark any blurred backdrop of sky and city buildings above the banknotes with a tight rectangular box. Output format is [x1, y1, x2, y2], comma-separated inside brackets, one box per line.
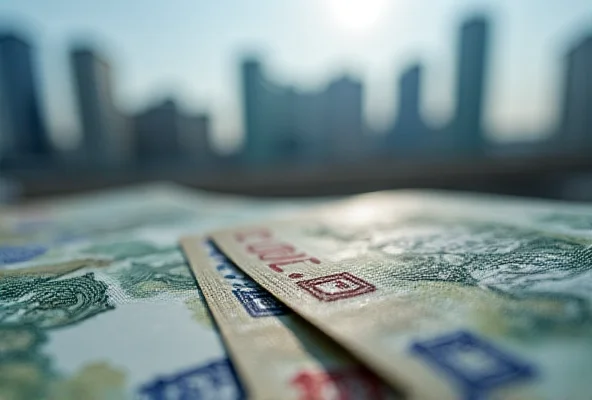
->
[0, 0, 592, 200]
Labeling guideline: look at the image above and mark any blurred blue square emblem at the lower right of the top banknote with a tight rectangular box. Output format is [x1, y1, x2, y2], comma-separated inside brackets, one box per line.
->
[411, 331, 535, 400]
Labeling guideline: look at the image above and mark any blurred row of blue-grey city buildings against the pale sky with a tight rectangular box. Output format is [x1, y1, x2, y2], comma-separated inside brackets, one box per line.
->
[0, 15, 592, 198]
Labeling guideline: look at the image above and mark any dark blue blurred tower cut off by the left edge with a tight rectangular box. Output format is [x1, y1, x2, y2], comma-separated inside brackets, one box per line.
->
[0, 33, 51, 162]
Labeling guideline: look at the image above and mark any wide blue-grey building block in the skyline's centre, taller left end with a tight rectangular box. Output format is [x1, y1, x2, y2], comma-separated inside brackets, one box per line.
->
[241, 59, 364, 164]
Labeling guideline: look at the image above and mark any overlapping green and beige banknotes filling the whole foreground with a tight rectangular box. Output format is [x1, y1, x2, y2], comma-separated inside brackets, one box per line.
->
[0, 184, 592, 400]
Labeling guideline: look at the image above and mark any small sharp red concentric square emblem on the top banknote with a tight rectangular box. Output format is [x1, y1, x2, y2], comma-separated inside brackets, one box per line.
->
[296, 272, 376, 301]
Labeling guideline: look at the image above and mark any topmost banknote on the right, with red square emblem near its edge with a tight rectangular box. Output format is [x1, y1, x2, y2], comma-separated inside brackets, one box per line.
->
[213, 191, 592, 399]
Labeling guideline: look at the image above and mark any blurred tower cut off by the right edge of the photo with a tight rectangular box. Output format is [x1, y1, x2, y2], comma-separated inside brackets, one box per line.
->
[559, 35, 592, 147]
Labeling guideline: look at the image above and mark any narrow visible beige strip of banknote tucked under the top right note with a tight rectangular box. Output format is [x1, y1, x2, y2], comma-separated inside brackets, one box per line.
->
[182, 237, 397, 400]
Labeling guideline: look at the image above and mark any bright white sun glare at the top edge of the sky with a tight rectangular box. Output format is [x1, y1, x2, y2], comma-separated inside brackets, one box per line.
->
[327, 0, 387, 31]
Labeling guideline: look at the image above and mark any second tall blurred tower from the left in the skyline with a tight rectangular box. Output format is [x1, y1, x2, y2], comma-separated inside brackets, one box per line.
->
[70, 47, 131, 166]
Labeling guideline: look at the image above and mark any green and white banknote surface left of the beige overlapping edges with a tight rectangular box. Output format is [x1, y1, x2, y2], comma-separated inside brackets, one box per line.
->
[0, 186, 310, 400]
